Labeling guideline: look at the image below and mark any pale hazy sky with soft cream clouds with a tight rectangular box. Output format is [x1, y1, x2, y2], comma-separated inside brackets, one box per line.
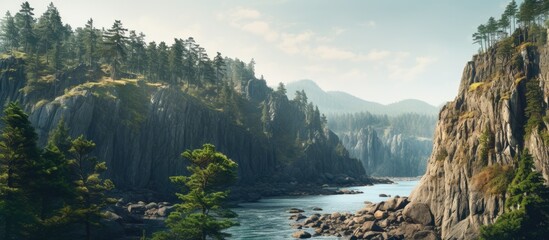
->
[0, 0, 509, 105]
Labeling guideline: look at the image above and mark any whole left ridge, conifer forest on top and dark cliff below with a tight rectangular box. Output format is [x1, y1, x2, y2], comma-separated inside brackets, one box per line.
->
[0, 2, 370, 239]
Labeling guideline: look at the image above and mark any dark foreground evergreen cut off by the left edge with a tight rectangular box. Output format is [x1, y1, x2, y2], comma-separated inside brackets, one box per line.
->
[0, 102, 43, 240]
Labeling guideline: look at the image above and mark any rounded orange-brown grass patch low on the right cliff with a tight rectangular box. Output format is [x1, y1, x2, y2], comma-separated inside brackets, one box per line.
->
[472, 164, 514, 195]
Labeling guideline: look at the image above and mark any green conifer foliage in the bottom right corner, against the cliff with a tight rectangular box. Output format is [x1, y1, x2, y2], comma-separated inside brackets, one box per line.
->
[480, 149, 549, 240]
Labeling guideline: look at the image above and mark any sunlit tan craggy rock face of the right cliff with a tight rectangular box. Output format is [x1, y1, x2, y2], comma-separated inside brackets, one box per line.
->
[410, 45, 549, 239]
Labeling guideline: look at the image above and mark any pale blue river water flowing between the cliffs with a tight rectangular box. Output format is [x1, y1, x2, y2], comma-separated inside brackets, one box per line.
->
[227, 181, 418, 239]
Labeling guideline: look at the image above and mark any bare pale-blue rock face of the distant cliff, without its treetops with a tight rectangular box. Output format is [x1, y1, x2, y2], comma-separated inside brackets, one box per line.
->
[338, 127, 432, 177]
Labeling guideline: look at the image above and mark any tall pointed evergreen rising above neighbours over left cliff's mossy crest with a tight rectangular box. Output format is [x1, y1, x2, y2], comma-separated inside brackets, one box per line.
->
[103, 20, 128, 80]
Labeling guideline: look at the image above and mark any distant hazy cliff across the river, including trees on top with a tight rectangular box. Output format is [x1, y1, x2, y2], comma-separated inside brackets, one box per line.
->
[328, 112, 436, 177]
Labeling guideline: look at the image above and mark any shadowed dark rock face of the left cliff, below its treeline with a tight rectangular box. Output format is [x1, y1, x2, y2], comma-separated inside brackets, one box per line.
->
[0, 58, 364, 195]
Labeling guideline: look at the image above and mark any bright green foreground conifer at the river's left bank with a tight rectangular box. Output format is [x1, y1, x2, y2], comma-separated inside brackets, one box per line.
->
[154, 144, 237, 240]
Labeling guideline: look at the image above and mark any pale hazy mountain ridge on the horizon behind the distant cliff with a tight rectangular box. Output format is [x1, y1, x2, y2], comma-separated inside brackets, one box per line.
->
[286, 80, 439, 115]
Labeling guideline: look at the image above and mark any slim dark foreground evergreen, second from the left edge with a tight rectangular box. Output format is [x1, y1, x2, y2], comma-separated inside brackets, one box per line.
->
[69, 136, 114, 240]
